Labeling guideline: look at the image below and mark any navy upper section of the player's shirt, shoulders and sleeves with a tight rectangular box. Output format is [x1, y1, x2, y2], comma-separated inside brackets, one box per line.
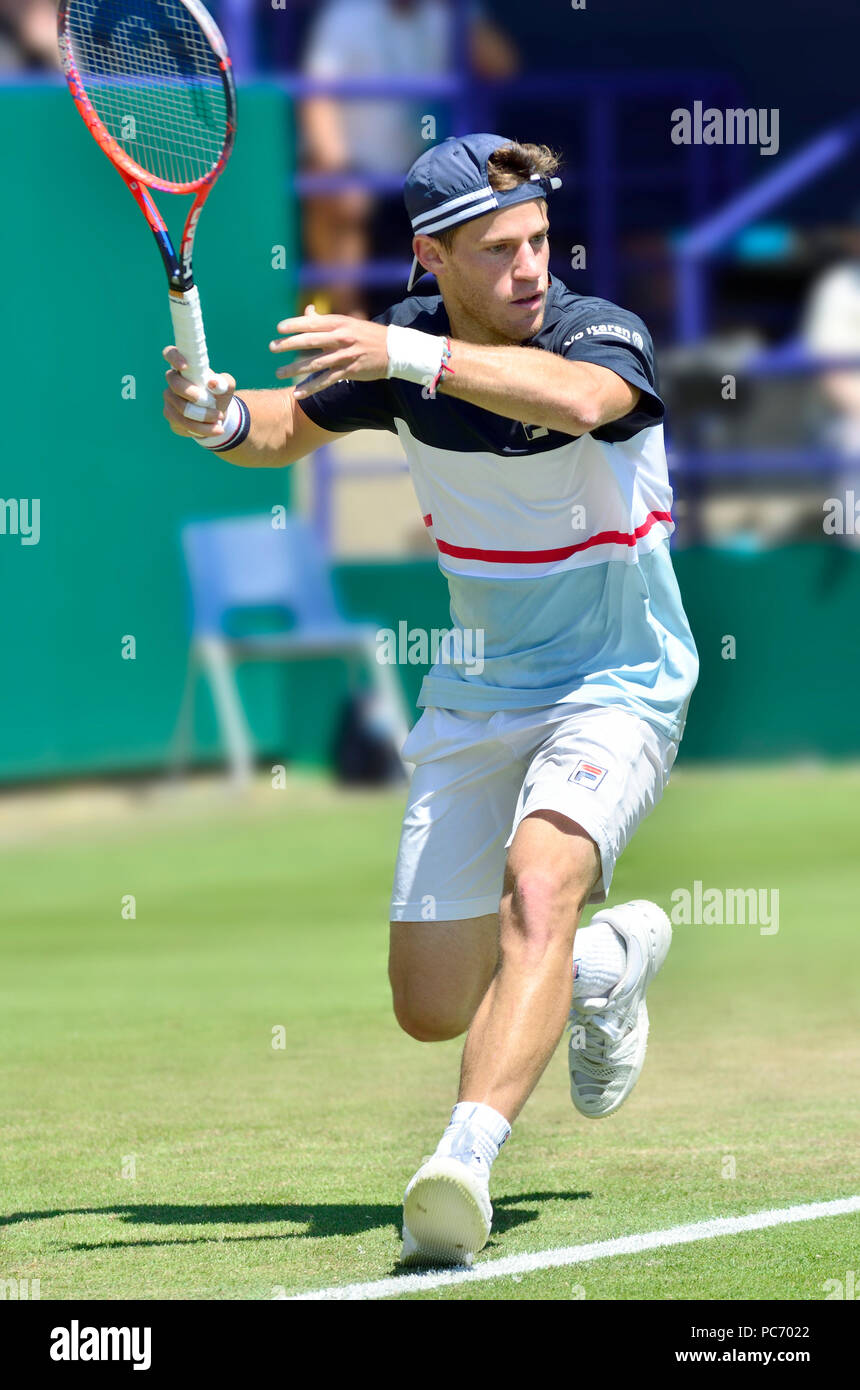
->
[301, 278, 663, 455]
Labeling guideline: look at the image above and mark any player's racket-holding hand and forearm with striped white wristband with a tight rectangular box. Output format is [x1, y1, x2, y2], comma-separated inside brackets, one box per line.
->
[163, 348, 339, 468]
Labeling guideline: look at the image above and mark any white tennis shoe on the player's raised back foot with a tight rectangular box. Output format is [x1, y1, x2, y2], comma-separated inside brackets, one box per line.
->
[568, 899, 672, 1119]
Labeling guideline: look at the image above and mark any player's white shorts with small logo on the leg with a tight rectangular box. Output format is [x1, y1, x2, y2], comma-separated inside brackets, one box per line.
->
[390, 705, 678, 922]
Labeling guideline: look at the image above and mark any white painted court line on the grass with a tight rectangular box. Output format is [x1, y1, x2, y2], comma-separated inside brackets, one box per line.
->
[288, 1197, 860, 1302]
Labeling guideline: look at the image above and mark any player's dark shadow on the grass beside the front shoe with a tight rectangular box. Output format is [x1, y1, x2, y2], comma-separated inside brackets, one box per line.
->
[0, 1193, 590, 1251]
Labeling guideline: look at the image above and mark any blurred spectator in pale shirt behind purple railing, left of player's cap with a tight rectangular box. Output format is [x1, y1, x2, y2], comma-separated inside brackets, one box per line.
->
[301, 0, 518, 314]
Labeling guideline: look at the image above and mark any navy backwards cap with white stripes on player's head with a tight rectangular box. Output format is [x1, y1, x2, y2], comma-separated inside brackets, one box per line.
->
[403, 135, 561, 291]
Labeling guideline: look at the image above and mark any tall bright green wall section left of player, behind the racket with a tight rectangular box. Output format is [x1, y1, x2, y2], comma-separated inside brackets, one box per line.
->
[0, 85, 296, 780]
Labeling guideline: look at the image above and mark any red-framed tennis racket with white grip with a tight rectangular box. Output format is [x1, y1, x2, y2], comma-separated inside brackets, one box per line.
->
[58, 0, 236, 420]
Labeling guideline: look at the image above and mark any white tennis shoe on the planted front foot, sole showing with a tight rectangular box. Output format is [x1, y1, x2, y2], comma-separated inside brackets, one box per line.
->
[400, 1154, 493, 1265]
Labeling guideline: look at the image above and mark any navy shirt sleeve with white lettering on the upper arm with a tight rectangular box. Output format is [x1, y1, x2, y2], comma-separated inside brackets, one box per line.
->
[553, 299, 664, 442]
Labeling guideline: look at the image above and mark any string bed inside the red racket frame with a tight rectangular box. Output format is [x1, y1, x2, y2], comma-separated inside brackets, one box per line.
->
[68, 0, 228, 183]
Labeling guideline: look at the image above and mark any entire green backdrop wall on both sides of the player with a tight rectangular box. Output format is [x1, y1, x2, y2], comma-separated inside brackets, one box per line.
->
[0, 88, 860, 783]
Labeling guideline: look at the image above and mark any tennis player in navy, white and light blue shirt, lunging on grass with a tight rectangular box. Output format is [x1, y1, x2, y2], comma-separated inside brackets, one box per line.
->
[165, 135, 697, 1264]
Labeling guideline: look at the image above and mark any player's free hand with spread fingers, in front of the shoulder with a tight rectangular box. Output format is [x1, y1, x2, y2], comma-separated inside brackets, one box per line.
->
[270, 304, 388, 400]
